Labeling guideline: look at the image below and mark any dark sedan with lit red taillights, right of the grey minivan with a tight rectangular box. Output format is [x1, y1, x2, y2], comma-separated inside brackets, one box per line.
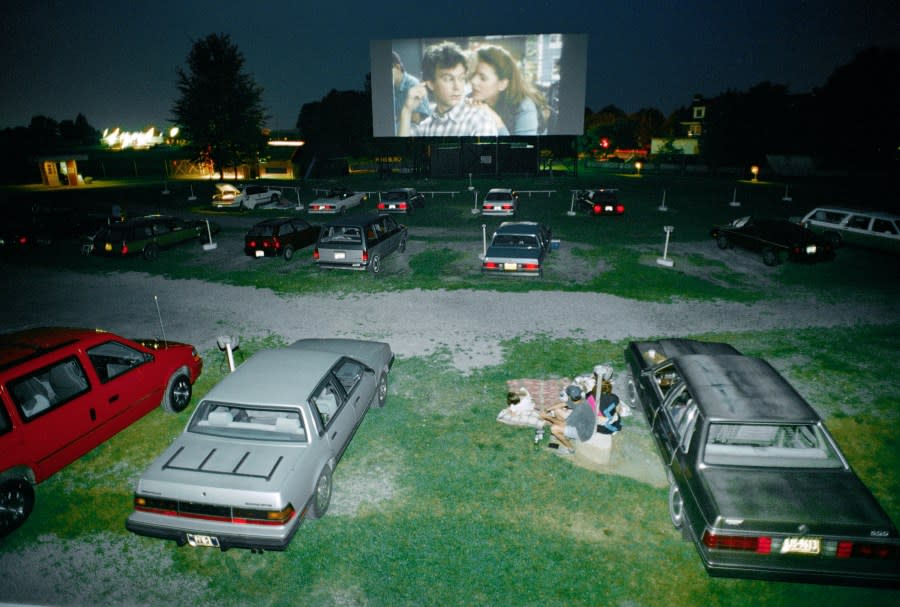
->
[481, 221, 551, 277]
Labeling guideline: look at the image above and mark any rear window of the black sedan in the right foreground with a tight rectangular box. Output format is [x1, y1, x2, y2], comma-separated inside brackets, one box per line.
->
[704, 423, 843, 468]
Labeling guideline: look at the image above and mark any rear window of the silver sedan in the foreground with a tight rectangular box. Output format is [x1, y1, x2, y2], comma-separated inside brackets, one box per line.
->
[188, 401, 307, 443]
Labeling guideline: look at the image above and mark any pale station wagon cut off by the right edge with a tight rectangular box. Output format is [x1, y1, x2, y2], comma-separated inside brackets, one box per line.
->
[800, 207, 900, 253]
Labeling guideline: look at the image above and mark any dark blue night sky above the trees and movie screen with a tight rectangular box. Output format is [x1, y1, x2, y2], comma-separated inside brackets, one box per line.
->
[0, 0, 900, 130]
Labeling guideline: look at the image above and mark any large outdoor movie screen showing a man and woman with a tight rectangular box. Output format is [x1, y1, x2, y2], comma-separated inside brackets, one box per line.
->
[370, 34, 587, 137]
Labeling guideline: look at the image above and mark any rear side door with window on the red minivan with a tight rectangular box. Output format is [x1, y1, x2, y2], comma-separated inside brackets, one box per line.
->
[6, 353, 101, 482]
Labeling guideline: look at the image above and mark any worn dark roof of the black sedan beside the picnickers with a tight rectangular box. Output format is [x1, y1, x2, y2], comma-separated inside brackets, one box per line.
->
[673, 354, 820, 422]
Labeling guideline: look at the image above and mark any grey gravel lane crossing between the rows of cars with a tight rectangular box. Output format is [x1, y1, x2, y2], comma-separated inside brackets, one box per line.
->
[0, 263, 897, 372]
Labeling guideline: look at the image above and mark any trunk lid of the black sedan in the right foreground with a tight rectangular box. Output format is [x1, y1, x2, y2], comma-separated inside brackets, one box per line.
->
[700, 468, 896, 536]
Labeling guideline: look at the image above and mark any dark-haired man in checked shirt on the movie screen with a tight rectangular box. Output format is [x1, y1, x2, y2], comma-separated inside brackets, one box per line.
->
[397, 42, 499, 137]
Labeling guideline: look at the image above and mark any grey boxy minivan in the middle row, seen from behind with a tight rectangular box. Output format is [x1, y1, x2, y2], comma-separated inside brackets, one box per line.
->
[313, 213, 409, 274]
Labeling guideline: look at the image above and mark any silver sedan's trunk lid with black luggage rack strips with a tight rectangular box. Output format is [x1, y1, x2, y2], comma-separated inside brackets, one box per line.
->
[138, 432, 308, 507]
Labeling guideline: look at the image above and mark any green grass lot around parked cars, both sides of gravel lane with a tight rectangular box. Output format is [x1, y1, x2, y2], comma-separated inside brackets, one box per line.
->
[0, 170, 900, 607]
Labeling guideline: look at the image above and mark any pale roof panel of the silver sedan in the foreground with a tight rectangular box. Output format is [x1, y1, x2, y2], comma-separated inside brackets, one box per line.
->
[204, 348, 341, 405]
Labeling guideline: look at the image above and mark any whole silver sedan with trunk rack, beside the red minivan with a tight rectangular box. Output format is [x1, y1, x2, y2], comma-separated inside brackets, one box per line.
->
[126, 339, 394, 551]
